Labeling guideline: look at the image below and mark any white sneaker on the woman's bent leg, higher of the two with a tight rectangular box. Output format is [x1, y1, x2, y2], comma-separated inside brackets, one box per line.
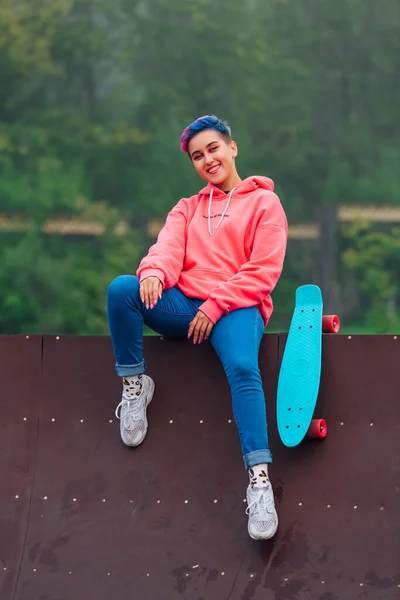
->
[115, 375, 155, 446]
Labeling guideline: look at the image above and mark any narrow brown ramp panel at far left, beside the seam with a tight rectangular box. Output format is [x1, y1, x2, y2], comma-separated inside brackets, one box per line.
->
[0, 336, 42, 599]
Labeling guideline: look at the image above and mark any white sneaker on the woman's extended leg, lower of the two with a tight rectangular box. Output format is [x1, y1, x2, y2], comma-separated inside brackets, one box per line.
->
[246, 482, 278, 540]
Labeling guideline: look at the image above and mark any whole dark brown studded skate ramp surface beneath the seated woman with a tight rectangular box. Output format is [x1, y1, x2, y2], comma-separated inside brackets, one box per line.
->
[0, 335, 400, 600]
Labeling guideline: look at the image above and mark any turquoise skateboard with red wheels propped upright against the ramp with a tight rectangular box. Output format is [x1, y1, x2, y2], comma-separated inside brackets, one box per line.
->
[277, 285, 340, 447]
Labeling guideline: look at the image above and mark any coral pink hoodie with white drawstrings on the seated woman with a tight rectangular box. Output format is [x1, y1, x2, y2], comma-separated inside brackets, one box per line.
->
[137, 177, 288, 325]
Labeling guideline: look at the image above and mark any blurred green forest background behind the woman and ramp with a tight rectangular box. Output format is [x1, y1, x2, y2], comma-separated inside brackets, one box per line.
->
[0, 0, 400, 334]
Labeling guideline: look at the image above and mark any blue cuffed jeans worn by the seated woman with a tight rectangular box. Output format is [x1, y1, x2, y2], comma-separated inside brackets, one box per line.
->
[107, 275, 272, 469]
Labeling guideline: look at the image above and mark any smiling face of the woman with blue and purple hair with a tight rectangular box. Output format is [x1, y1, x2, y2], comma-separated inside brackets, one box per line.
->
[188, 129, 238, 189]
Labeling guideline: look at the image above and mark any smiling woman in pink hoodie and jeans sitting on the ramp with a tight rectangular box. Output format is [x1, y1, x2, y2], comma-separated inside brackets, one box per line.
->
[107, 115, 287, 539]
